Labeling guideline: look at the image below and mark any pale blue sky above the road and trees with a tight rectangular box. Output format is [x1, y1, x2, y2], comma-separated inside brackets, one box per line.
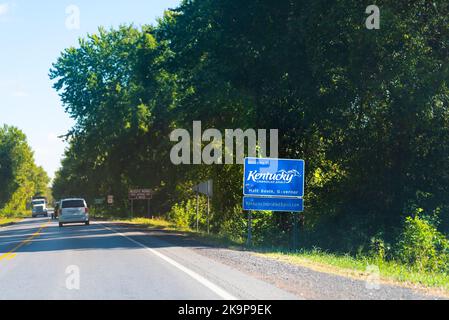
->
[0, 0, 180, 177]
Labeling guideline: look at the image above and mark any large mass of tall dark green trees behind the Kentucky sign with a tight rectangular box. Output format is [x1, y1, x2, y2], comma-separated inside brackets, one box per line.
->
[50, 0, 449, 259]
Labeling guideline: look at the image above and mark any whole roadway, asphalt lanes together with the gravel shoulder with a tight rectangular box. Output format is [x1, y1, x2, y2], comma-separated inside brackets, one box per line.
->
[0, 218, 446, 300]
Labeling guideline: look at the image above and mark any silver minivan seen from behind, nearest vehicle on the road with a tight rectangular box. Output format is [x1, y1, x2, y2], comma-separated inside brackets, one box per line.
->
[58, 198, 90, 228]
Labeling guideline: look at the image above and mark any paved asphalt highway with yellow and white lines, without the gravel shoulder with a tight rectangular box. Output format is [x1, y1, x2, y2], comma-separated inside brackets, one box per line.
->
[0, 219, 298, 300]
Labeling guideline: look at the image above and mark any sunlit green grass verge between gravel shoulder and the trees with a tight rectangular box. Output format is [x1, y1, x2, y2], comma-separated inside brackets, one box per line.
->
[112, 218, 449, 295]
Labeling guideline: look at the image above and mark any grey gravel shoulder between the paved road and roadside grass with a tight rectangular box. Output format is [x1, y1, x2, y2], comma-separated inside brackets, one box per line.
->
[110, 224, 445, 300]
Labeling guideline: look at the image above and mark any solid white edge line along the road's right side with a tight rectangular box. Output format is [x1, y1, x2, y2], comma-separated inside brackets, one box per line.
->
[101, 224, 237, 300]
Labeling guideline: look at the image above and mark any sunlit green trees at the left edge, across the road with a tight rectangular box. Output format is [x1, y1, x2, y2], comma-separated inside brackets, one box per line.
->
[0, 125, 50, 216]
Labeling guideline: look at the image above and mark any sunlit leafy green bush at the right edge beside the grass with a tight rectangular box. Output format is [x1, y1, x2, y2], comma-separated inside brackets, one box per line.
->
[398, 215, 449, 272]
